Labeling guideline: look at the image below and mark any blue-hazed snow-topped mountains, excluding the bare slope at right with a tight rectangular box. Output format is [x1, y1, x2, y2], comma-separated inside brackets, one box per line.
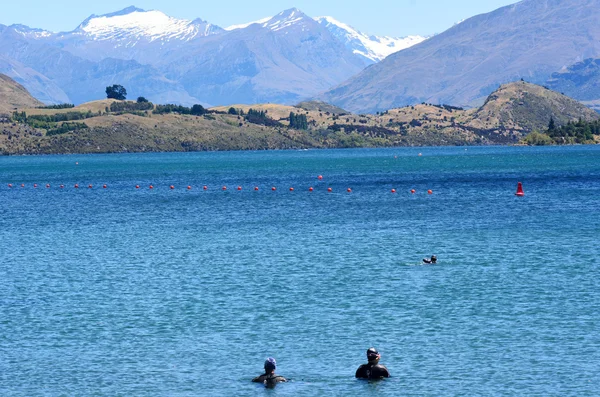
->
[0, 6, 425, 106]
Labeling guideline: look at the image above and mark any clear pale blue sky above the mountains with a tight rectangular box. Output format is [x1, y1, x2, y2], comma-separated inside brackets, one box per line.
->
[0, 0, 517, 36]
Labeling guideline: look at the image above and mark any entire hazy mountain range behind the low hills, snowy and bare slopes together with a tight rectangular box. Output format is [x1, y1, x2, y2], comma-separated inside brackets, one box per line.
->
[0, 0, 600, 113]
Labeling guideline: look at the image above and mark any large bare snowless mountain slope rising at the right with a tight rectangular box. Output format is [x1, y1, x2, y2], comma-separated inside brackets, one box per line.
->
[320, 0, 600, 112]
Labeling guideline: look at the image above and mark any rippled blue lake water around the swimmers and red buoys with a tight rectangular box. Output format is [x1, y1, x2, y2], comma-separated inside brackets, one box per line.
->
[0, 146, 600, 396]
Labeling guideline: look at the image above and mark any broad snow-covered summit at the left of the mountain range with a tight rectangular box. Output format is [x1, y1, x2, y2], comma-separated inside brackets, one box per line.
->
[76, 6, 221, 43]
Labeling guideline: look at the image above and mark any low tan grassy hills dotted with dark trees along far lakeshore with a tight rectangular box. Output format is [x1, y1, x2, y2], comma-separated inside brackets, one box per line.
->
[0, 75, 600, 154]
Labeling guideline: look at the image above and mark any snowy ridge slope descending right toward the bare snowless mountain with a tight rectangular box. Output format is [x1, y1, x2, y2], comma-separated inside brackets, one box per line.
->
[315, 16, 427, 62]
